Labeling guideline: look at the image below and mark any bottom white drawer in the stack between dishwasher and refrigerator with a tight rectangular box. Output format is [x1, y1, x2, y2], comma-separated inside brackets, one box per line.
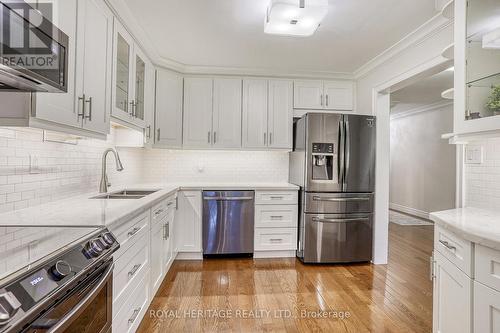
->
[254, 228, 297, 251]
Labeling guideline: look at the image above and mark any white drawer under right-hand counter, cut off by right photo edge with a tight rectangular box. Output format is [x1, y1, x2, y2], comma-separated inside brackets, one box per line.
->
[474, 245, 500, 291]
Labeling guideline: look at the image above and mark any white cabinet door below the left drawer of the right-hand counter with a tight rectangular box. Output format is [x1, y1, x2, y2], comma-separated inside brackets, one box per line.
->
[433, 252, 472, 333]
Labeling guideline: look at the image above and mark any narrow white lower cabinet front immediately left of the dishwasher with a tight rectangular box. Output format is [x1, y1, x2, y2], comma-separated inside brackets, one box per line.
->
[175, 191, 202, 255]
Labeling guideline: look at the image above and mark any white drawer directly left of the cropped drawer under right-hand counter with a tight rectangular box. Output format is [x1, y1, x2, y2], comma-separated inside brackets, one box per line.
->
[434, 226, 472, 276]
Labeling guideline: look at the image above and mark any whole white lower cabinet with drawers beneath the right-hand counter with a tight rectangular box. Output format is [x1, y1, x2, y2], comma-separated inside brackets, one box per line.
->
[432, 226, 500, 333]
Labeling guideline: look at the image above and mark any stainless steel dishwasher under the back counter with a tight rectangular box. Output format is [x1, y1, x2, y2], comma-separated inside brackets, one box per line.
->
[203, 191, 255, 255]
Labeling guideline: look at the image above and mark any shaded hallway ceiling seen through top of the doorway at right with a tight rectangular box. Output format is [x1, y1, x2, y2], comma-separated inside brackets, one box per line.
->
[391, 70, 454, 114]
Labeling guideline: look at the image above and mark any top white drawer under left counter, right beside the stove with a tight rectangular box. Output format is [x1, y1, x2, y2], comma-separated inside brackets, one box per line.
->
[112, 210, 150, 260]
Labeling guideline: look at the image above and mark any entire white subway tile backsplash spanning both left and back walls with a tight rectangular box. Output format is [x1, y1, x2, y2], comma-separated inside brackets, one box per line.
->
[0, 127, 288, 213]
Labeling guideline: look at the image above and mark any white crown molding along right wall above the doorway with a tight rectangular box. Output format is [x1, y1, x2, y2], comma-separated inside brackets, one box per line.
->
[353, 13, 453, 79]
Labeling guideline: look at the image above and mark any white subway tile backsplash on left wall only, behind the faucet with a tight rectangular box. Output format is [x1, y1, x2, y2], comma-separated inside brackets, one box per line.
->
[0, 128, 143, 213]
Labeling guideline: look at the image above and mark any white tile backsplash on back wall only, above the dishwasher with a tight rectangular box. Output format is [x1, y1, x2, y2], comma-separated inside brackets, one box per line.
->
[144, 150, 288, 183]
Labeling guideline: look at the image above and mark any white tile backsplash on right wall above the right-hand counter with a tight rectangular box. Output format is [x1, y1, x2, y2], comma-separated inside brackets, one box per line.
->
[465, 138, 500, 210]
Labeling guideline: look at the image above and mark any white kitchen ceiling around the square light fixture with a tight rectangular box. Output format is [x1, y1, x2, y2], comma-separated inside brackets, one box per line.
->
[124, 0, 436, 73]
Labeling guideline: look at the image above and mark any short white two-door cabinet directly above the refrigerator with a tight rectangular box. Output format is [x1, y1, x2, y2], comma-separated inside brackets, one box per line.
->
[294, 80, 354, 111]
